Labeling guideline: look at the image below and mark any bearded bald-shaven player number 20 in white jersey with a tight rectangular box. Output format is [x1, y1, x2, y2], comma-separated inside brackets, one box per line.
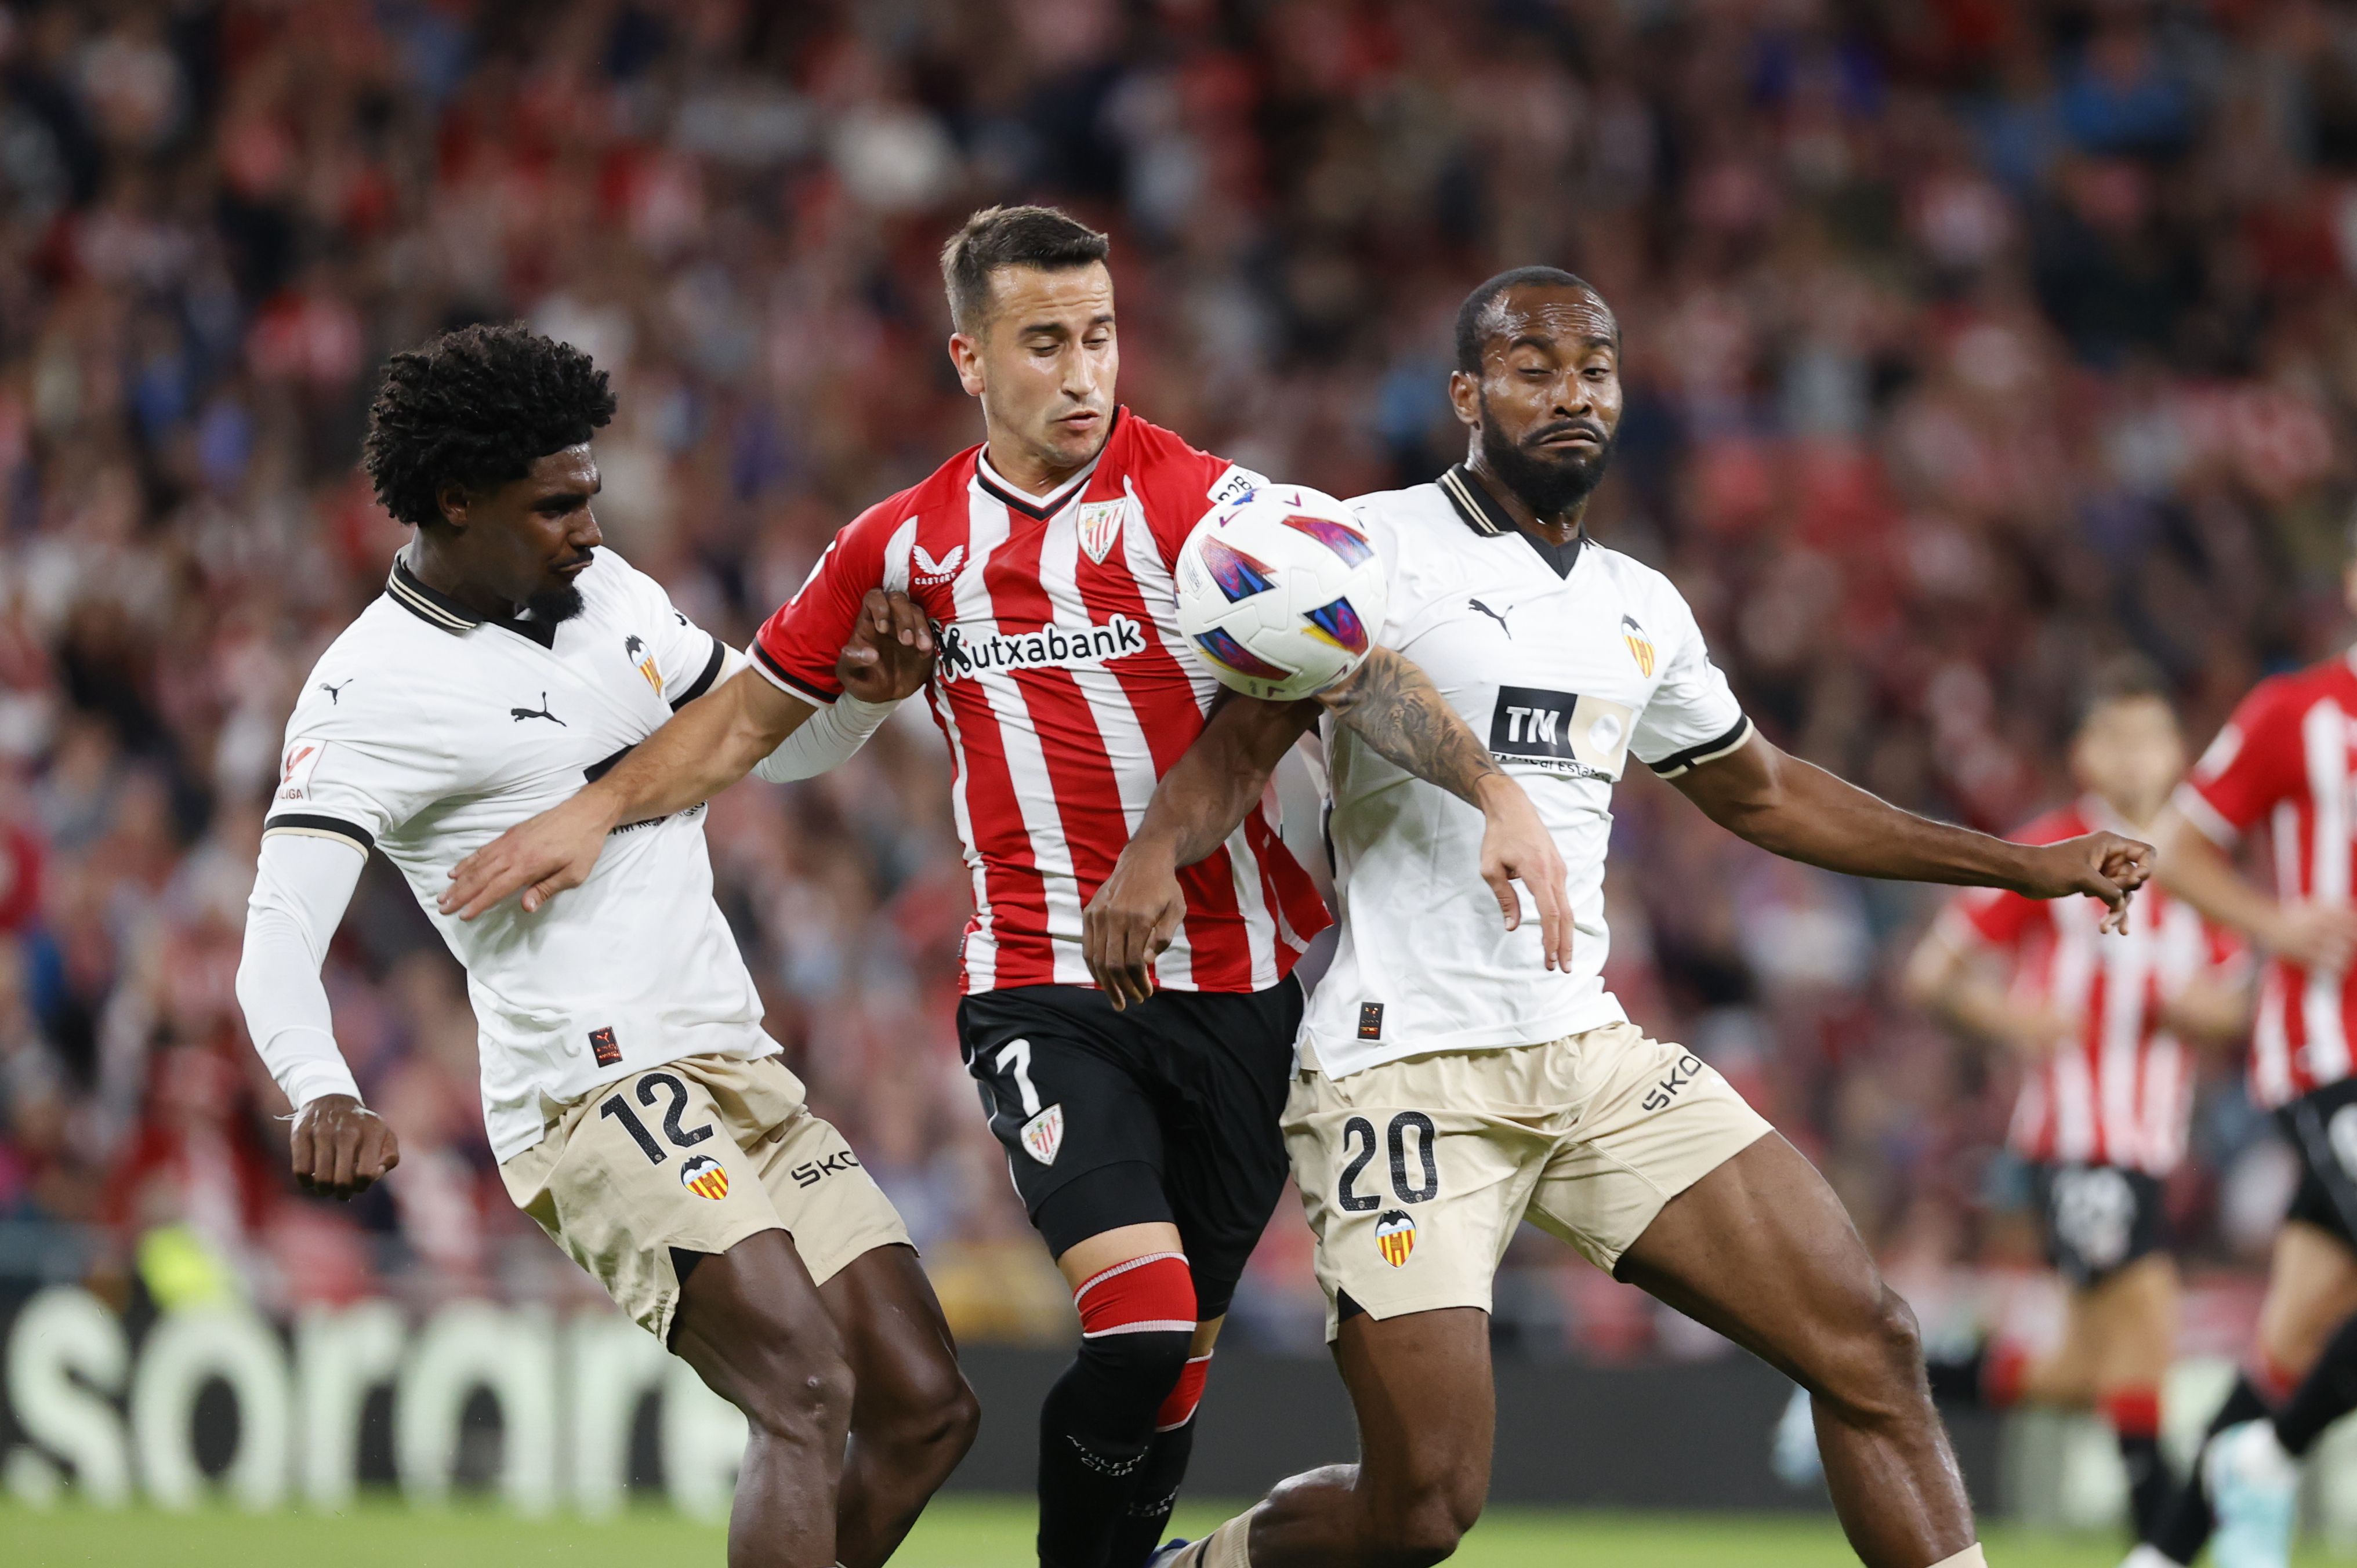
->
[1089, 266, 2149, 1568]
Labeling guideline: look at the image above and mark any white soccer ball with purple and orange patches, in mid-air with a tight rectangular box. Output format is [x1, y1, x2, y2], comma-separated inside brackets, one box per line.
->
[1178, 486, 1391, 703]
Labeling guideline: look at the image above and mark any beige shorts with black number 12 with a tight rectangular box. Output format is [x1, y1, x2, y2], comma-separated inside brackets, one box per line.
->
[500, 1057, 908, 1344]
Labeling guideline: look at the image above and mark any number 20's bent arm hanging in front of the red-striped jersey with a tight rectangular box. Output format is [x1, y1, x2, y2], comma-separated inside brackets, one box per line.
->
[1079, 693, 1318, 1009]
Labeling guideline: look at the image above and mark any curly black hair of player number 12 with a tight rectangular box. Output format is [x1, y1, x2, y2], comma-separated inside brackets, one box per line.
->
[361, 323, 615, 528]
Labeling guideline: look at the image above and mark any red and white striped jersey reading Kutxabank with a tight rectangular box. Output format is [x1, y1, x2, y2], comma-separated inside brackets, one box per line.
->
[754, 408, 1329, 993]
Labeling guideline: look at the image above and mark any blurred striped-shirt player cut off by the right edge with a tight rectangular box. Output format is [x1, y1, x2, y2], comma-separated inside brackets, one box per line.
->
[2131, 564, 2357, 1568]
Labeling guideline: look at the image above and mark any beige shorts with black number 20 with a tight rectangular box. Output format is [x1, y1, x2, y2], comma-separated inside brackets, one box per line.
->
[1285, 1023, 1770, 1340]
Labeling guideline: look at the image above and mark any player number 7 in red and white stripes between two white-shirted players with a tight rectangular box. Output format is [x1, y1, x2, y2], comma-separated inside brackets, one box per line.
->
[443, 208, 1572, 1568]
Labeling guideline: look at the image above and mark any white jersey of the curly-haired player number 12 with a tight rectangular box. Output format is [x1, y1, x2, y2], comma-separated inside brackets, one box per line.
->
[264, 549, 759, 1160]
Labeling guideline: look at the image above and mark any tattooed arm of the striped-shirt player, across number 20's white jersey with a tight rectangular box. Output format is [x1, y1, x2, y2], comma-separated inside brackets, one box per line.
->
[1318, 648, 1572, 969]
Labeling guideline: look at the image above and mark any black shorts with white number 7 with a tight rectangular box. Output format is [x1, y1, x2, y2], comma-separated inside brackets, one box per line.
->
[957, 978, 1301, 1318]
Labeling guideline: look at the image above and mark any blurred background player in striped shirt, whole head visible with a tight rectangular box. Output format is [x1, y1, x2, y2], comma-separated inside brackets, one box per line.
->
[1907, 658, 2249, 1540]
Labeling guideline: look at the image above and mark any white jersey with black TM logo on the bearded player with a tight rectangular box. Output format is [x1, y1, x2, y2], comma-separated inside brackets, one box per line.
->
[1301, 467, 1752, 1077]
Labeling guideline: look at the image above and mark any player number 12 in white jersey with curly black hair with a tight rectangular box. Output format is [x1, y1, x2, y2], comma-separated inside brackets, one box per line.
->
[238, 328, 978, 1568]
